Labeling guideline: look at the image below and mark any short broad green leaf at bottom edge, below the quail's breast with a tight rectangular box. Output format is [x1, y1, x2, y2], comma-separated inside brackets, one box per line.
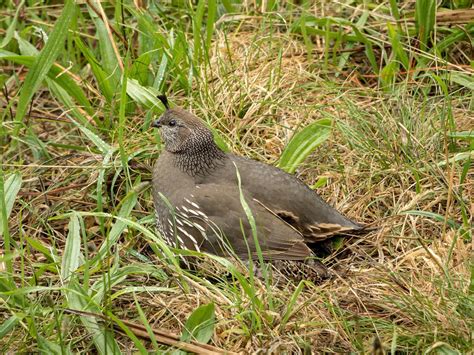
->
[181, 303, 216, 343]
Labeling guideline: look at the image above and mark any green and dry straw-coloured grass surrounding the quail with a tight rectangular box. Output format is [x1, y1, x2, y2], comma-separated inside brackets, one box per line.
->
[0, 0, 474, 354]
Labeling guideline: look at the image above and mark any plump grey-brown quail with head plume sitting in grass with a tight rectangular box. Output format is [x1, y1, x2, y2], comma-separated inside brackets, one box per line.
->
[151, 95, 364, 279]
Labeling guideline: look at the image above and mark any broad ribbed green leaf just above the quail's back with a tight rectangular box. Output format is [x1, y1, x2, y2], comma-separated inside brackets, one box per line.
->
[278, 118, 332, 173]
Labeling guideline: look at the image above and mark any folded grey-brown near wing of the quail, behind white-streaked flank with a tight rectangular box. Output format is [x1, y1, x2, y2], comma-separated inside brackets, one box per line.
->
[168, 183, 311, 260]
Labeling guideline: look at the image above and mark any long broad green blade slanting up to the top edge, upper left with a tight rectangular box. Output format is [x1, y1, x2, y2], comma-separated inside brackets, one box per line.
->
[14, 0, 76, 136]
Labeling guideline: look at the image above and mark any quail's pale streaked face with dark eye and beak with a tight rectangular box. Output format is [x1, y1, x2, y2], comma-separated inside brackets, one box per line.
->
[151, 110, 193, 153]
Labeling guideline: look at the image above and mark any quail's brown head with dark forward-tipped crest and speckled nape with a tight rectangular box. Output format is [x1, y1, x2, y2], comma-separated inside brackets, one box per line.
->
[151, 96, 214, 153]
